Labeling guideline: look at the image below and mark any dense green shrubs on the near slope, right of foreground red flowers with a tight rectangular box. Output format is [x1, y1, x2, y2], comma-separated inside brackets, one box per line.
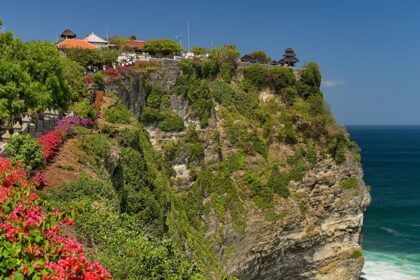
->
[42, 173, 204, 280]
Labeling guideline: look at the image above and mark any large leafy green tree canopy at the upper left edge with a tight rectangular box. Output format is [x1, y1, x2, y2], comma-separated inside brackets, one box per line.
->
[0, 24, 83, 120]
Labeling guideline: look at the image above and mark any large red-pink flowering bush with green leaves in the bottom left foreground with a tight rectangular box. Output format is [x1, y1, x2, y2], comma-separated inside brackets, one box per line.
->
[0, 158, 111, 280]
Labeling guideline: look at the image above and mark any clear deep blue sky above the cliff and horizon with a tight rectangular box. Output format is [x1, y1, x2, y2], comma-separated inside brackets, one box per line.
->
[0, 0, 420, 124]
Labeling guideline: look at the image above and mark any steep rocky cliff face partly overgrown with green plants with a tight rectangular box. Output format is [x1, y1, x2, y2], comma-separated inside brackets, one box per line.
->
[107, 63, 370, 279]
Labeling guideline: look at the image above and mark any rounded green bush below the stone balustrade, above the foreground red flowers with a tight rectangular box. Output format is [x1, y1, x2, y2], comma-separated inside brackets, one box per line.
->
[6, 134, 44, 170]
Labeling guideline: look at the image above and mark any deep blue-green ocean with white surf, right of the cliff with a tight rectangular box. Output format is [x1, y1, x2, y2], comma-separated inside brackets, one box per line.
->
[347, 126, 420, 280]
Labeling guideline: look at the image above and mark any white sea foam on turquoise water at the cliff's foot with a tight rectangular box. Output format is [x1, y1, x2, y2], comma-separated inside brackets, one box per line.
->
[362, 250, 420, 280]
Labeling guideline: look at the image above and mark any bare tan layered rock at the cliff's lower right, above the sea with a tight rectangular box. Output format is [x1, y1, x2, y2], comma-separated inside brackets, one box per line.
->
[225, 160, 370, 279]
